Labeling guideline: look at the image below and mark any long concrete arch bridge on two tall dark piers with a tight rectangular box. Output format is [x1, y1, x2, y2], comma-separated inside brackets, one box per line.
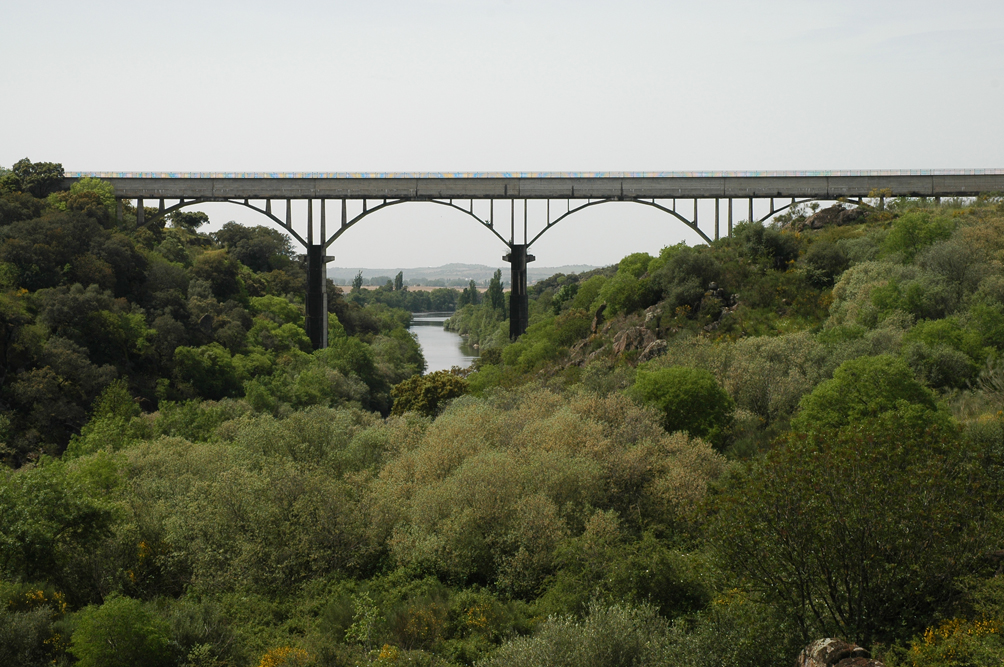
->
[64, 169, 1004, 349]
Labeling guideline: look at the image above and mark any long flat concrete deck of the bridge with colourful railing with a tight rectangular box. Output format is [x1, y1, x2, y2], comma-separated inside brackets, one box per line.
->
[66, 169, 1004, 200]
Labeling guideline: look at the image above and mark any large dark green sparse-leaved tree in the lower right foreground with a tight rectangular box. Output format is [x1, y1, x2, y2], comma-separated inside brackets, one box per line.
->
[710, 412, 999, 646]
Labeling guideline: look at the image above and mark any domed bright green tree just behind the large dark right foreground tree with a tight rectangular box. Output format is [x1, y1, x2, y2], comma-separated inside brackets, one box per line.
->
[791, 355, 937, 432]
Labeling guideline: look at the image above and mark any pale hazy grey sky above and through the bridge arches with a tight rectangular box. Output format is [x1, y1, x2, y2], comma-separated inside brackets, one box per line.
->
[0, 0, 1004, 267]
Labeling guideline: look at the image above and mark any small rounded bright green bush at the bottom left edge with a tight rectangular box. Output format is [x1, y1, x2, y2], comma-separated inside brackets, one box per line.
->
[69, 596, 175, 667]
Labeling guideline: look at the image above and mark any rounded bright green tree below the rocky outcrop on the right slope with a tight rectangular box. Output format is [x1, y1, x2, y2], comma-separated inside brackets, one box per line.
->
[628, 365, 735, 444]
